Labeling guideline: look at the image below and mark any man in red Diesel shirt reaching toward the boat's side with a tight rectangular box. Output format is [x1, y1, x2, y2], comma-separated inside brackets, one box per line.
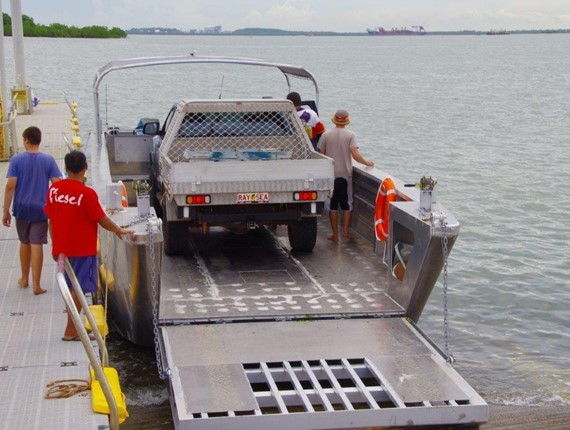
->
[44, 151, 134, 341]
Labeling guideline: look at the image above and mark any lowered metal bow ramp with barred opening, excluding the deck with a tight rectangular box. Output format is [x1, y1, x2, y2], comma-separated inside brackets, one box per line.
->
[161, 318, 487, 430]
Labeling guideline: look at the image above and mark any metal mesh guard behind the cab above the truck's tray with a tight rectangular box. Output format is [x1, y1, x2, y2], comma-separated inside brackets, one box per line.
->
[161, 100, 311, 162]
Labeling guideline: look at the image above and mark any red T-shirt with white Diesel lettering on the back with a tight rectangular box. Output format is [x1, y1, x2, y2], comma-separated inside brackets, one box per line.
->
[44, 179, 106, 257]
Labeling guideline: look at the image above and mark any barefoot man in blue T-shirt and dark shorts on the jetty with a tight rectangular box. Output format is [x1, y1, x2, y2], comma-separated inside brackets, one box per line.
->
[2, 126, 62, 295]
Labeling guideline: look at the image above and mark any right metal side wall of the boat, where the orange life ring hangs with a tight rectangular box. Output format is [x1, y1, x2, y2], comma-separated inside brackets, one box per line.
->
[351, 165, 460, 322]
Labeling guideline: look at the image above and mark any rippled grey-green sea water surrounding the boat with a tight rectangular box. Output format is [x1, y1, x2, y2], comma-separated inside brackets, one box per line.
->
[5, 34, 570, 429]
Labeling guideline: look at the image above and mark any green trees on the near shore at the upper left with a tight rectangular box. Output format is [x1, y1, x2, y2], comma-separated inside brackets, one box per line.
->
[3, 13, 127, 39]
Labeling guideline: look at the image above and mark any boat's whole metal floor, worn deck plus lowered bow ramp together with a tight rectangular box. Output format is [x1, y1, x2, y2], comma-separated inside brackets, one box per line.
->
[155, 220, 487, 429]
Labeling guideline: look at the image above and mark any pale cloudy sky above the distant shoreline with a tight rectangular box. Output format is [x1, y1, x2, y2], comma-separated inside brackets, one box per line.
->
[4, 0, 570, 32]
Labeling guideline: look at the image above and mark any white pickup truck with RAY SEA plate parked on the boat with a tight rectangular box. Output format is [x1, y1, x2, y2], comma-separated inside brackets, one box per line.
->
[151, 99, 334, 255]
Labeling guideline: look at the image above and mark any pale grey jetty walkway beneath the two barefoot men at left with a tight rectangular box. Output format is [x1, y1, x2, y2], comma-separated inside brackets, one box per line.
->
[0, 104, 109, 430]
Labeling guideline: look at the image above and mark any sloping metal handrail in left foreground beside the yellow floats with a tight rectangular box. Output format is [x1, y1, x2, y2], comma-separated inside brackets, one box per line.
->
[56, 254, 119, 430]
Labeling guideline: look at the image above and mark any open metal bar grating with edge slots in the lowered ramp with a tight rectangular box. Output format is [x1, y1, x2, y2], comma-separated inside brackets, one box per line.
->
[185, 358, 470, 419]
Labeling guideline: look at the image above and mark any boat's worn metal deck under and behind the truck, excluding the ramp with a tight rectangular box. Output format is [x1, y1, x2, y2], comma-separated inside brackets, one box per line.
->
[159, 225, 404, 324]
